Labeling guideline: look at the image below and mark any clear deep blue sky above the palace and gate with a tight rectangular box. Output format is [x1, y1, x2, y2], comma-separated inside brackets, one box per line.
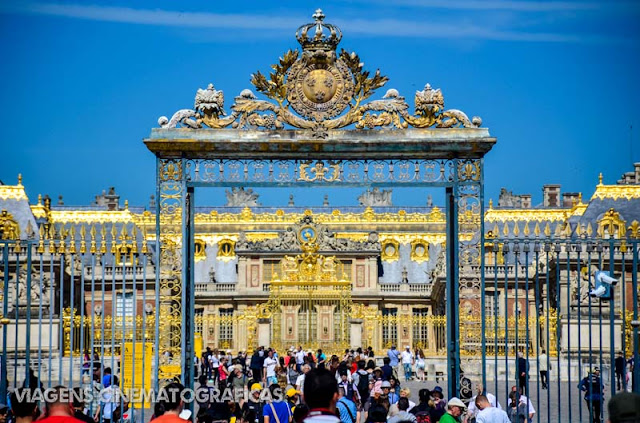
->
[0, 0, 640, 210]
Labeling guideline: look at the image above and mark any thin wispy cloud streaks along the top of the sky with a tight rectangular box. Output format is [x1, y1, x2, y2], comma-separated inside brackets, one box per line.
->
[0, 0, 632, 42]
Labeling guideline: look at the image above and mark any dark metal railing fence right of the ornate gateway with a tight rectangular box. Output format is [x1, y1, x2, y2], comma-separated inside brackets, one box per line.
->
[480, 237, 640, 422]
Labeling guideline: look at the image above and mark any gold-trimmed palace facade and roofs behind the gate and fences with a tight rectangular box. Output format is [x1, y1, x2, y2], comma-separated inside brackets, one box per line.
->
[0, 163, 640, 357]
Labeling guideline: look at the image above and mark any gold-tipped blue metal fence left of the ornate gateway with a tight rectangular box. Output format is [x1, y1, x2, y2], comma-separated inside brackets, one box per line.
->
[0, 235, 158, 421]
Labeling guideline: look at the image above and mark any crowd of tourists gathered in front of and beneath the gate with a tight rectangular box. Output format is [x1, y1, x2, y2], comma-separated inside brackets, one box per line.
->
[0, 346, 640, 423]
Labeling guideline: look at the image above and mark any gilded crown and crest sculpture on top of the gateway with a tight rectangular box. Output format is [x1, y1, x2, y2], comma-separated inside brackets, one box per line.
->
[158, 9, 482, 139]
